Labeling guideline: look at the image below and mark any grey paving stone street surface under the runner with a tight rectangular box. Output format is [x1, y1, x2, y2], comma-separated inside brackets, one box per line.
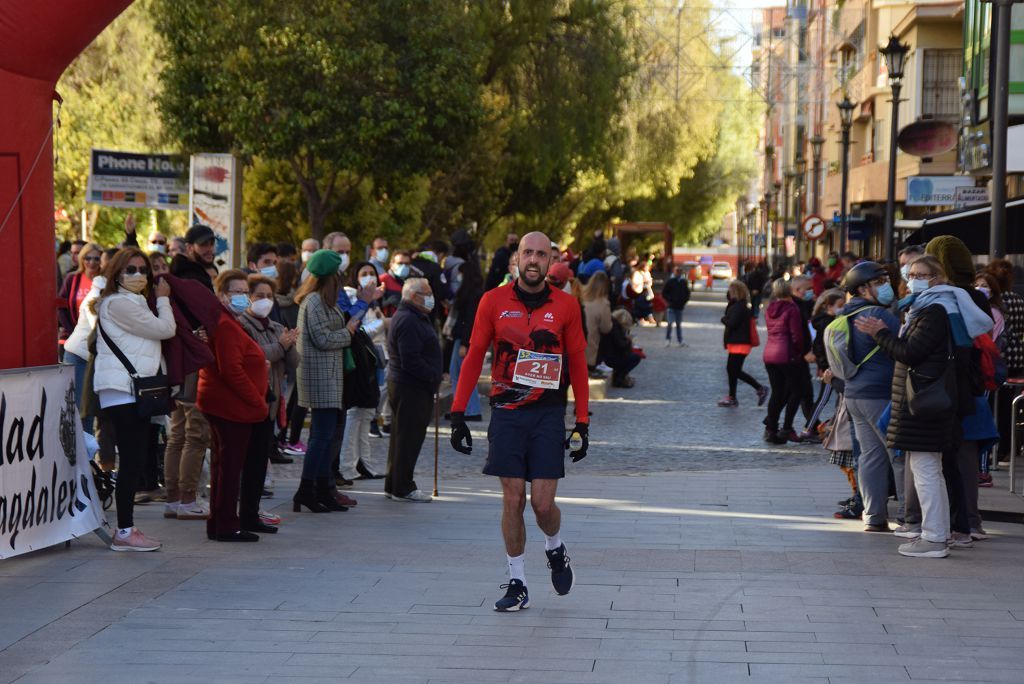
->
[0, 295, 1024, 684]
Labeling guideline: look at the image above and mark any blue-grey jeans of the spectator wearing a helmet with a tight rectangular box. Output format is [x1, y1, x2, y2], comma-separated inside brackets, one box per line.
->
[846, 396, 904, 525]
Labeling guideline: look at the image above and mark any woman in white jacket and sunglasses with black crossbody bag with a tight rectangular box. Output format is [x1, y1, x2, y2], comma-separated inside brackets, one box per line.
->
[92, 247, 175, 551]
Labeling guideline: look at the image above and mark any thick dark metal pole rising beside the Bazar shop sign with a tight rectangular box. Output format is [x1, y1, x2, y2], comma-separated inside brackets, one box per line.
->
[988, 0, 1013, 259]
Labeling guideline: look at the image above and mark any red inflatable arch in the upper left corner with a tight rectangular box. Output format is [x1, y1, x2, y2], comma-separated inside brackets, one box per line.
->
[0, 0, 131, 369]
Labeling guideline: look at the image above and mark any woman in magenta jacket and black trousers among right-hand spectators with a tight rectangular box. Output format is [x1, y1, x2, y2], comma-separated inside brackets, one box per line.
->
[764, 277, 806, 444]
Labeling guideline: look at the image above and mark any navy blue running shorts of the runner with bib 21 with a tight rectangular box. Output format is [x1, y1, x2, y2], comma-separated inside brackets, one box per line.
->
[483, 407, 565, 481]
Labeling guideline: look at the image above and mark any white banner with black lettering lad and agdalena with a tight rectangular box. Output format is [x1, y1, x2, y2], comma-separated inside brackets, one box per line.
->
[0, 366, 103, 559]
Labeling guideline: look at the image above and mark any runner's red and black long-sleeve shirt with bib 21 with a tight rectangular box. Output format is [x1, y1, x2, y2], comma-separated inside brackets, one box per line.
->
[452, 284, 590, 423]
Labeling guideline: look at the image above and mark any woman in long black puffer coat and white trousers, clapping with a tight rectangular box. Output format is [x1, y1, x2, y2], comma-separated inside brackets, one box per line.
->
[854, 257, 959, 558]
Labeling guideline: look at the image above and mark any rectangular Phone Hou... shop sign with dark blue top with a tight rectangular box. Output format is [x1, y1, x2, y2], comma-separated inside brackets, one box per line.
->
[86, 149, 188, 211]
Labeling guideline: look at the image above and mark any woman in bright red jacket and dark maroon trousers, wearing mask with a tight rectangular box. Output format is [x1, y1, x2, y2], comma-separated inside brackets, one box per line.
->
[196, 270, 268, 542]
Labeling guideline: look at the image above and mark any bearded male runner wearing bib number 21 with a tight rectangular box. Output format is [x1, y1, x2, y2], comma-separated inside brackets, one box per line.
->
[452, 232, 590, 612]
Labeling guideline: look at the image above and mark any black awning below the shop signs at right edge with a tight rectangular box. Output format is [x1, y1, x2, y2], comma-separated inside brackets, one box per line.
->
[896, 197, 1024, 254]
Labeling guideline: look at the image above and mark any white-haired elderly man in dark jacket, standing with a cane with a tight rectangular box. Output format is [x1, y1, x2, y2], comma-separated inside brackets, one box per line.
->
[384, 277, 441, 503]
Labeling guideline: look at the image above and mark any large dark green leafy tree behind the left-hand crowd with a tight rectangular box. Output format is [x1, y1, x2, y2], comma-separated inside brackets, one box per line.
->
[157, 0, 481, 238]
